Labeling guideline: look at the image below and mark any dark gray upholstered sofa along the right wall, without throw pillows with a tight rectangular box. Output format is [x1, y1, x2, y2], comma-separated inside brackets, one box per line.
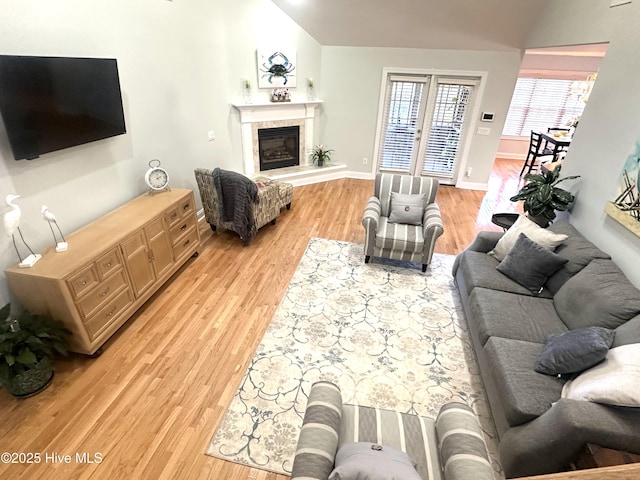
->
[453, 222, 640, 478]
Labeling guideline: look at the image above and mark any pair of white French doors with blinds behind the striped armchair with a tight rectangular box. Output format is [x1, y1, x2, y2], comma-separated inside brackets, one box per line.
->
[378, 74, 478, 184]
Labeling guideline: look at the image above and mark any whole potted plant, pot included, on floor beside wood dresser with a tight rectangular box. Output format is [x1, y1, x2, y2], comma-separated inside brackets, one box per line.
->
[0, 304, 70, 397]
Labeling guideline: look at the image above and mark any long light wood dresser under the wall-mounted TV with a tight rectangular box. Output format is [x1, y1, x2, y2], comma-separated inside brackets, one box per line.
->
[5, 189, 200, 355]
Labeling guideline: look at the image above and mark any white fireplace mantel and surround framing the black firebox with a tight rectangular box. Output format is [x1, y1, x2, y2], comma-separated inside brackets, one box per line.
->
[232, 100, 323, 175]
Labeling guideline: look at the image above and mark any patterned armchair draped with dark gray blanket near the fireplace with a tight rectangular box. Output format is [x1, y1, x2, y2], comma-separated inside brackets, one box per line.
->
[195, 168, 293, 245]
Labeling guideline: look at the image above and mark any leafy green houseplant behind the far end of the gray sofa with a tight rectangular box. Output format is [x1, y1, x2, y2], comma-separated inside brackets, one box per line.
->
[510, 166, 580, 227]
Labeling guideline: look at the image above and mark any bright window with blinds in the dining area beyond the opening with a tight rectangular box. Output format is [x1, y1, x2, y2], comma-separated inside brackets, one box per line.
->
[502, 77, 585, 137]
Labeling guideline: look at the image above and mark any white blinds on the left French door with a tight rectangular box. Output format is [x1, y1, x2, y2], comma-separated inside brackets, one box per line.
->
[380, 76, 426, 171]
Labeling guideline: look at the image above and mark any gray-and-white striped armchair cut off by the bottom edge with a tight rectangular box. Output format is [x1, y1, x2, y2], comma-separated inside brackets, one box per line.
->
[291, 382, 494, 480]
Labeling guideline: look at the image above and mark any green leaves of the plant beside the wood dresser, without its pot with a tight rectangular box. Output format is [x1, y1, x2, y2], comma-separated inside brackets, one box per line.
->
[0, 304, 71, 381]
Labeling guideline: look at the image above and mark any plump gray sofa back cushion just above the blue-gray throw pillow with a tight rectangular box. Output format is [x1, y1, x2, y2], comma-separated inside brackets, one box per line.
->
[553, 260, 640, 330]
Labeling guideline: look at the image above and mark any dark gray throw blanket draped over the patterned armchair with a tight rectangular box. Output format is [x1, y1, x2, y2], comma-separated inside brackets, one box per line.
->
[213, 168, 260, 245]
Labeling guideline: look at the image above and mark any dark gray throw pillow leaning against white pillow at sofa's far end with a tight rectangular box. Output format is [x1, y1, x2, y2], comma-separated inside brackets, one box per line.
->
[496, 233, 567, 295]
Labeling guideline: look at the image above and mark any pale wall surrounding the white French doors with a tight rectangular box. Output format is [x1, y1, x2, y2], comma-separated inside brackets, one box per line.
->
[321, 47, 521, 187]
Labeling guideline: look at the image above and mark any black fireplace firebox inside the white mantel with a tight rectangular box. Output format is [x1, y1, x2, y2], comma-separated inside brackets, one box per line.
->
[258, 125, 300, 171]
